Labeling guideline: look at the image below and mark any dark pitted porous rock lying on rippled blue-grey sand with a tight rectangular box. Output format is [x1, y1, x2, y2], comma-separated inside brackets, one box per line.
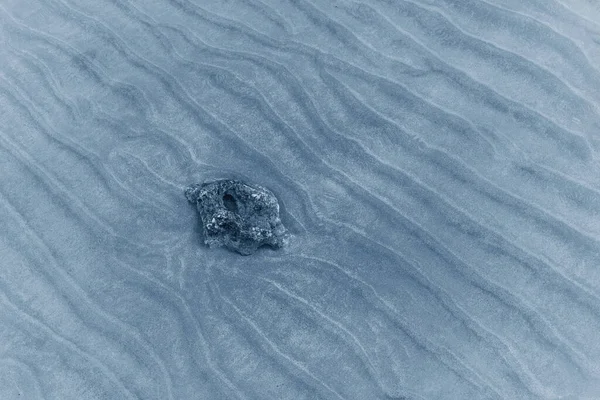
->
[185, 179, 287, 255]
